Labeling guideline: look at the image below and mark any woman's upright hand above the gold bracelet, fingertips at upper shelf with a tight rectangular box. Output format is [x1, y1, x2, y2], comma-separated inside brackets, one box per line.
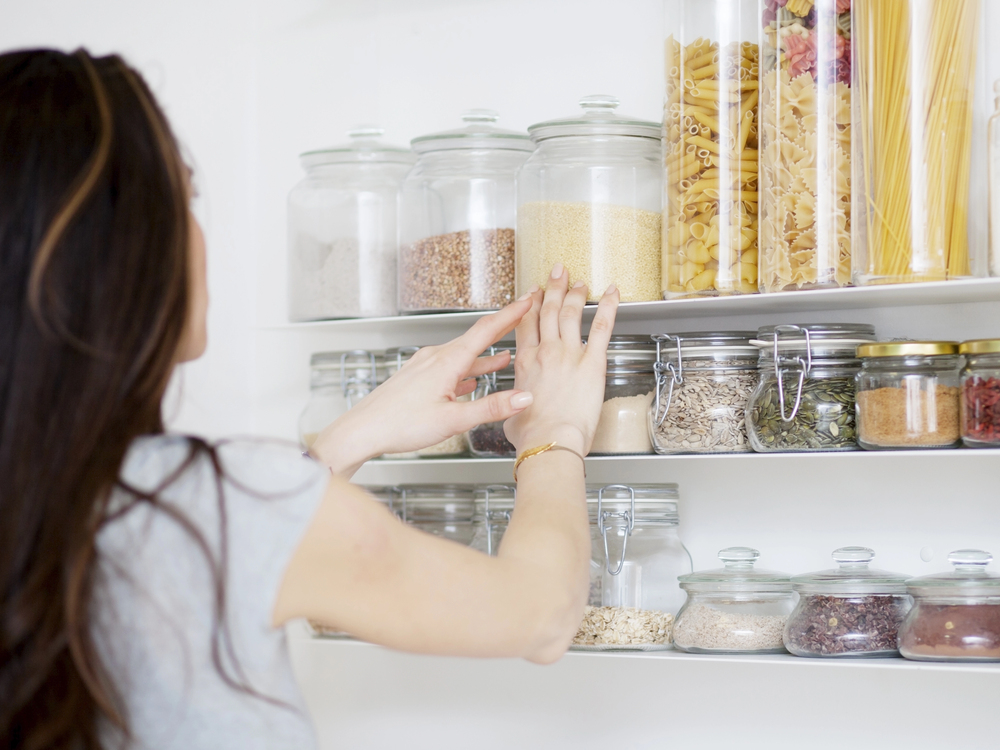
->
[504, 264, 619, 456]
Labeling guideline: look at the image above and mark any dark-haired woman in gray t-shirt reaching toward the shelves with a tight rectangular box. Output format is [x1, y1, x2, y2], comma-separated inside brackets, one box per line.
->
[0, 50, 618, 749]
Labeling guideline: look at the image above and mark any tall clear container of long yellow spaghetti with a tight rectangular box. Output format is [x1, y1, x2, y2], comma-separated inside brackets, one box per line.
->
[851, 0, 988, 284]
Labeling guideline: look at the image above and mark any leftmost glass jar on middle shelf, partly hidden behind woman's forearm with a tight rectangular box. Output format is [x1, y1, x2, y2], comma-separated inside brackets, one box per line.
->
[299, 349, 379, 448]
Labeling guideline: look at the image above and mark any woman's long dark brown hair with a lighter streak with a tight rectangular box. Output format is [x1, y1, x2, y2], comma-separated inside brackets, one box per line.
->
[0, 50, 195, 750]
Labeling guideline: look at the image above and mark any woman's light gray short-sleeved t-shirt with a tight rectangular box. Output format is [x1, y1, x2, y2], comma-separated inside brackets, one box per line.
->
[92, 435, 330, 750]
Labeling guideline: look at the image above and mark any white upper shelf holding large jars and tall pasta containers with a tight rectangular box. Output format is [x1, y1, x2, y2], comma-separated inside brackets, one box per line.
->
[274, 278, 1000, 332]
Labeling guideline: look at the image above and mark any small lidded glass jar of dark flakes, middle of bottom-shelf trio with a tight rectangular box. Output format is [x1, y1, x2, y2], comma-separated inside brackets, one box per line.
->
[784, 547, 911, 657]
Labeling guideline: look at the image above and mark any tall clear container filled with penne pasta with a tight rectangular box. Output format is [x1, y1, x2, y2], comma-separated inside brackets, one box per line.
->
[663, 0, 761, 298]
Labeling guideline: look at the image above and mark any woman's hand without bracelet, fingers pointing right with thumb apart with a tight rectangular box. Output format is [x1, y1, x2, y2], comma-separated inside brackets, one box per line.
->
[310, 295, 532, 477]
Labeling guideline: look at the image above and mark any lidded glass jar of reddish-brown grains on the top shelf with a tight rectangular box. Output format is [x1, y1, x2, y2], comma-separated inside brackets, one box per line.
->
[399, 109, 534, 313]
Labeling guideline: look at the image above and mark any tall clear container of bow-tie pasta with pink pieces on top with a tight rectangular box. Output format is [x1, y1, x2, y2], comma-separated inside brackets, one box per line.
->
[760, 0, 851, 292]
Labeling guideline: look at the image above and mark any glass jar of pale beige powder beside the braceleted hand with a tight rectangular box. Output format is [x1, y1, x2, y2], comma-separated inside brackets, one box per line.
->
[590, 336, 656, 455]
